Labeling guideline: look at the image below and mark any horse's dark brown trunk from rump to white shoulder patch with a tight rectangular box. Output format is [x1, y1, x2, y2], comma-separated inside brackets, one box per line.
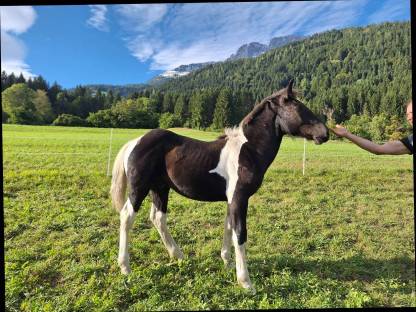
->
[128, 129, 225, 201]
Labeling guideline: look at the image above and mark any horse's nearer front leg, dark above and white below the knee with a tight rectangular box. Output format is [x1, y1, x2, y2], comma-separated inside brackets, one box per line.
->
[229, 193, 256, 293]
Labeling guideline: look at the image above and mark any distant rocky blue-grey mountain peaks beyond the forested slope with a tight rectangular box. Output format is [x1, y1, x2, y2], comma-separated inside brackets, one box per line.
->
[147, 35, 305, 87]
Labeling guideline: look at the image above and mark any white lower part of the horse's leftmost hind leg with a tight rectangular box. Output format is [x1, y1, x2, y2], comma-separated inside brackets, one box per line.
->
[118, 199, 136, 274]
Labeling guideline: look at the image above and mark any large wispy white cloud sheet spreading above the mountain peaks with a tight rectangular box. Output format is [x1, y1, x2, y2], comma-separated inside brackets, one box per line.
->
[112, 0, 404, 70]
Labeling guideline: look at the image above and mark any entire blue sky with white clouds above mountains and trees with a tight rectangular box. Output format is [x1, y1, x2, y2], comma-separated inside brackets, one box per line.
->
[0, 0, 410, 88]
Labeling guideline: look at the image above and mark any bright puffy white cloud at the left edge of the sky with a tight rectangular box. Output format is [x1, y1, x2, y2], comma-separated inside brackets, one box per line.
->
[0, 6, 37, 78]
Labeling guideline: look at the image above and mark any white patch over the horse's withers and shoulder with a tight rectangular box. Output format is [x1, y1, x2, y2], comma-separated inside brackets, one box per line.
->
[209, 127, 247, 203]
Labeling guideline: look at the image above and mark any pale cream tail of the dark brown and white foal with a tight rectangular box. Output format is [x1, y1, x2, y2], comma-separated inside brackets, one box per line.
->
[110, 141, 131, 212]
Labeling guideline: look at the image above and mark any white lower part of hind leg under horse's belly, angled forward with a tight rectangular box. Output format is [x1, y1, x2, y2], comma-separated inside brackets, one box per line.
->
[150, 204, 183, 259]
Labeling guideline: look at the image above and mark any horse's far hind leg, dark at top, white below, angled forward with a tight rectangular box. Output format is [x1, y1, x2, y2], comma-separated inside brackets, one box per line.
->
[150, 186, 183, 259]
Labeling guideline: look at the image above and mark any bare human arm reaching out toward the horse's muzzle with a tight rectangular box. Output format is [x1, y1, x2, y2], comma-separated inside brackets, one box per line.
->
[330, 125, 409, 155]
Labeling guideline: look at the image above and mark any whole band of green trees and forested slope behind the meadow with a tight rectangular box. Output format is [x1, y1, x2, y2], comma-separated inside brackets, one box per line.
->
[2, 22, 411, 140]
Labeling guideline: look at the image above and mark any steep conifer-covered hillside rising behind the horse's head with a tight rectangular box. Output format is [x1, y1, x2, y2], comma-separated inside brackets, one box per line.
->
[159, 22, 411, 121]
